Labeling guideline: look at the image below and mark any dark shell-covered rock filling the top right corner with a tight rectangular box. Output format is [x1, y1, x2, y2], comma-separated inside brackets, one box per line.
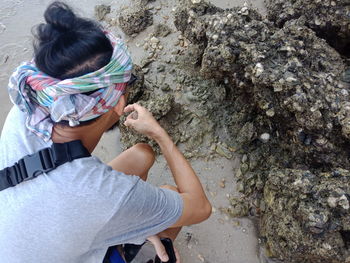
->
[265, 0, 350, 56]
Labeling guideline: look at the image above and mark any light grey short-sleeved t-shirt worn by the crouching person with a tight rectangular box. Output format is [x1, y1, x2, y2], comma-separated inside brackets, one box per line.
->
[0, 107, 183, 263]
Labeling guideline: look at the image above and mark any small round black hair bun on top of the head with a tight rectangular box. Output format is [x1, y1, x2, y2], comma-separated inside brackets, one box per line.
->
[44, 1, 76, 31]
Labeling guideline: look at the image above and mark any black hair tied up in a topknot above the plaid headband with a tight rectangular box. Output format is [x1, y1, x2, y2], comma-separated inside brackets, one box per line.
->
[34, 1, 113, 79]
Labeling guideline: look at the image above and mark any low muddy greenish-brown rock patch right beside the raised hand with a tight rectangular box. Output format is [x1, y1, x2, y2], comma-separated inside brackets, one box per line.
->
[120, 66, 231, 158]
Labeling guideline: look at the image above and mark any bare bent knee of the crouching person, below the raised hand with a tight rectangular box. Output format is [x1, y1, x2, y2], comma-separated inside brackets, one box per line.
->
[108, 143, 155, 181]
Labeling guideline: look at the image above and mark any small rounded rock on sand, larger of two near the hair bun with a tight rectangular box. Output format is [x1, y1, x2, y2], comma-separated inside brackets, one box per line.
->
[118, 2, 153, 36]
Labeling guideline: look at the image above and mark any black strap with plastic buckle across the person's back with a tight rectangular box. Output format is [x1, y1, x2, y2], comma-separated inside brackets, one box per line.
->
[0, 140, 91, 191]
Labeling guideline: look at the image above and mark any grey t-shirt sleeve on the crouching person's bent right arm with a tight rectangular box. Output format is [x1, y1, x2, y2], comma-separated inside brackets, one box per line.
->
[95, 175, 183, 246]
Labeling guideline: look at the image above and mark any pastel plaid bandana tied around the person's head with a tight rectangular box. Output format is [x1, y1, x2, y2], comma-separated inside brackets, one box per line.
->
[8, 32, 132, 141]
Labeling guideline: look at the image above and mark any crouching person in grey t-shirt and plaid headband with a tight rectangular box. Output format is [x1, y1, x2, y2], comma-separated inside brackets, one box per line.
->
[0, 2, 211, 263]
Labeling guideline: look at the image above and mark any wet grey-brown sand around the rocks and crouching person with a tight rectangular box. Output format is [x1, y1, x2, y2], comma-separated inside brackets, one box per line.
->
[0, 0, 264, 263]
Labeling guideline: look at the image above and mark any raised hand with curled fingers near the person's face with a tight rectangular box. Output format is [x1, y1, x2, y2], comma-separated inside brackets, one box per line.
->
[124, 103, 164, 139]
